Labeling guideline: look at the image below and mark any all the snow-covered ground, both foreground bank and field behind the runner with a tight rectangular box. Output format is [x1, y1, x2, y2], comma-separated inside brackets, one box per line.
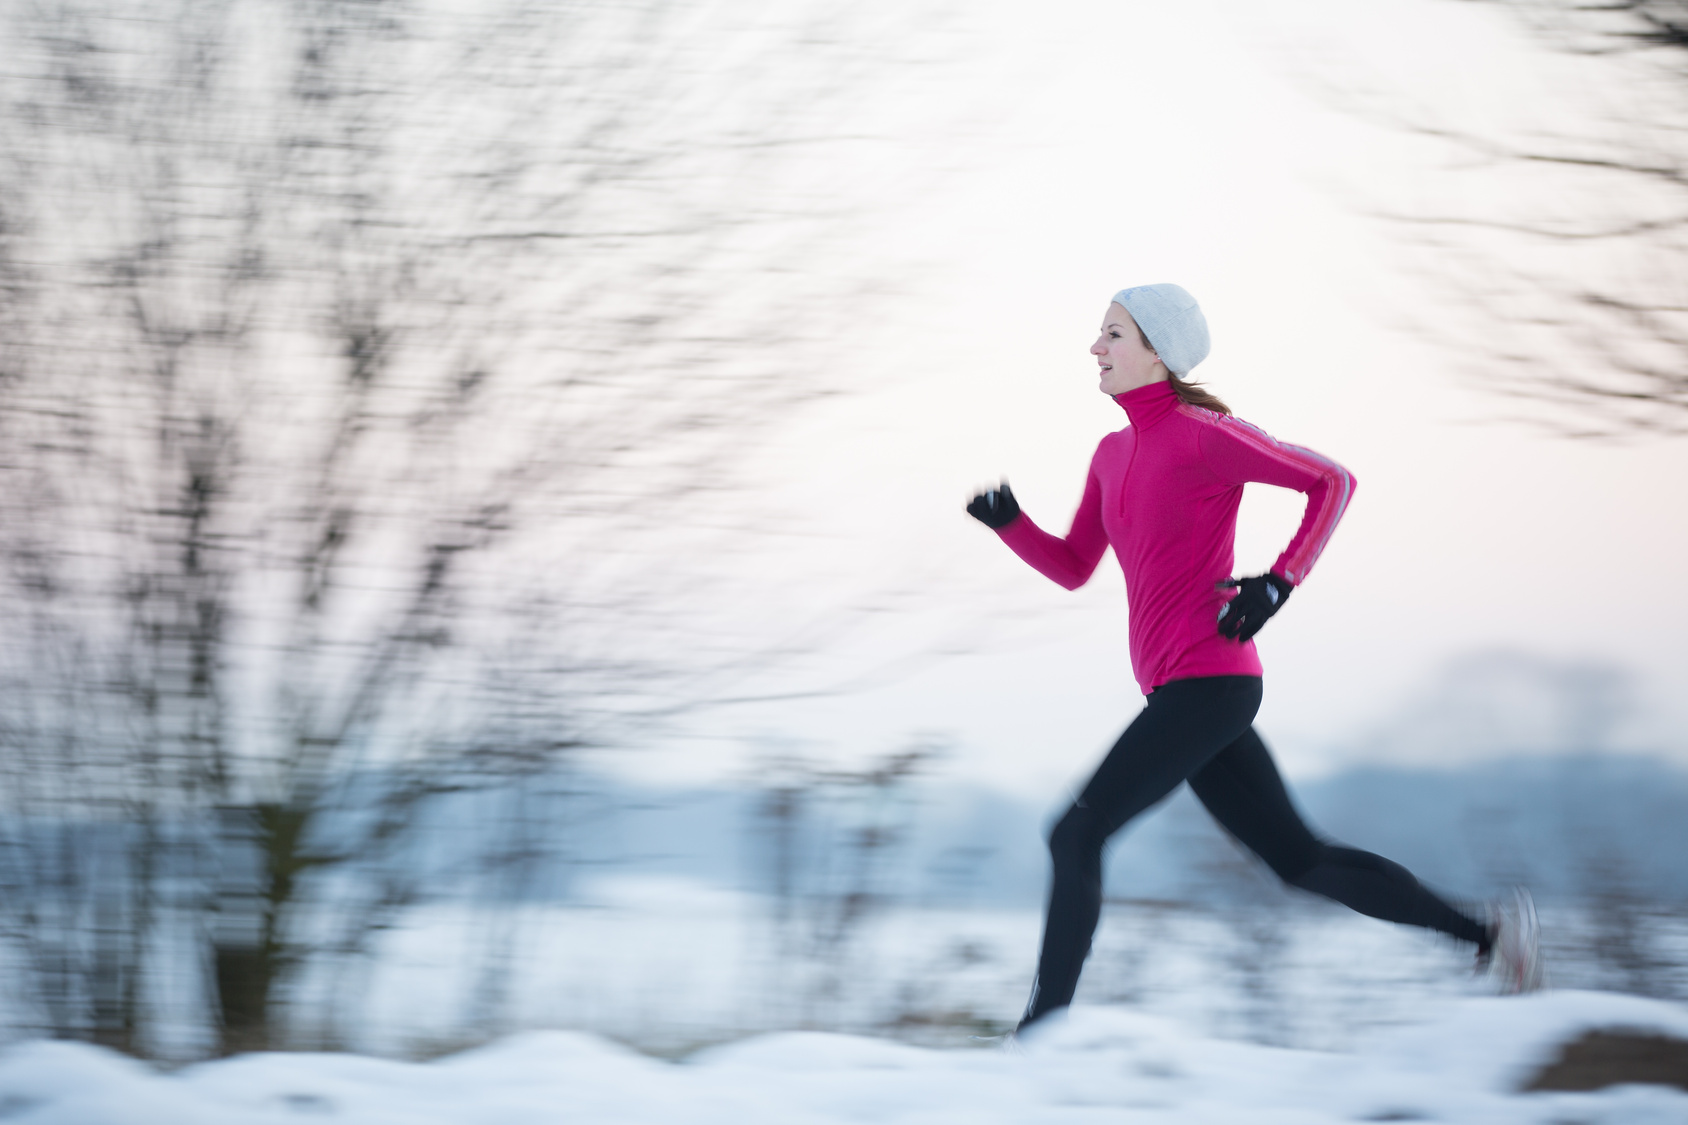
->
[0, 878, 1688, 1125]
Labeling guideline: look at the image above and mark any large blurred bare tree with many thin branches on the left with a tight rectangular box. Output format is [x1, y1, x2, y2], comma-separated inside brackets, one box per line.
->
[0, 0, 952, 1051]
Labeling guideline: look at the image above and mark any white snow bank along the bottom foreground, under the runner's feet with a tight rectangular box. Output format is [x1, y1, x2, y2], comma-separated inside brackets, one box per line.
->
[0, 992, 1688, 1125]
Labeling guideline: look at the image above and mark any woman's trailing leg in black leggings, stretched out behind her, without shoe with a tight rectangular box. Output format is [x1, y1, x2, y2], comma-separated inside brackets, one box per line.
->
[1190, 726, 1489, 948]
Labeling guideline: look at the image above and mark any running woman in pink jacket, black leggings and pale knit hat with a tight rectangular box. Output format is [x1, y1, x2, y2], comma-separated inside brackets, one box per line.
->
[967, 284, 1541, 1030]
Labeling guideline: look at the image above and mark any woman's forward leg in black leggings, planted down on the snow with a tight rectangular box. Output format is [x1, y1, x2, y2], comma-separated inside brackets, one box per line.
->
[1020, 676, 1261, 1027]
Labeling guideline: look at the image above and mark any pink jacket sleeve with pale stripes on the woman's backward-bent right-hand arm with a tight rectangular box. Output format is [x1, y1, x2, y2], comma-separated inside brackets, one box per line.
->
[1200, 417, 1355, 586]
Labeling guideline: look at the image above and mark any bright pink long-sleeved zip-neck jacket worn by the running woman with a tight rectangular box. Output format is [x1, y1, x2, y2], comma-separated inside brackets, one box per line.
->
[996, 382, 1354, 694]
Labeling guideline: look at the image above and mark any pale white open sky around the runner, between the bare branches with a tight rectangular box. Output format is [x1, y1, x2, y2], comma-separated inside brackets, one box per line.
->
[614, 0, 1688, 802]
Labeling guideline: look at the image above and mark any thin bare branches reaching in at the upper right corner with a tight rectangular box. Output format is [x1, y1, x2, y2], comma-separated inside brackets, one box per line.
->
[1344, 0, 1688, 430]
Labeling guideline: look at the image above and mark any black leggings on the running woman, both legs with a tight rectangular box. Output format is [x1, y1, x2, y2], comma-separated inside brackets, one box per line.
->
[1021, 676, 1487, 1025]
